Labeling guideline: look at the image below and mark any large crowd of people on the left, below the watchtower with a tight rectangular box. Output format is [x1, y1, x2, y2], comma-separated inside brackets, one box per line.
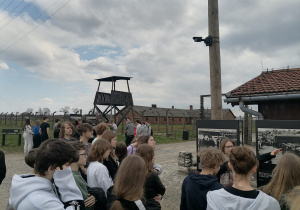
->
[1, 117, 165, 210]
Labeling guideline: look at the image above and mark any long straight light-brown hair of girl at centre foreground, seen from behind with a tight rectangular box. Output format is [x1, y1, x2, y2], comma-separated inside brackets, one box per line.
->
[110, 155, 146, 210]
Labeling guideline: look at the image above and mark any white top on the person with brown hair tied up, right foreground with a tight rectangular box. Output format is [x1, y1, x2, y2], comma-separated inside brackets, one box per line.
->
[207, 189, 280, 210]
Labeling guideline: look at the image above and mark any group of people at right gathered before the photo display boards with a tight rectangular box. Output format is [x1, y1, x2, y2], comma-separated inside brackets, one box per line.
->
[180, 138, 300, 210]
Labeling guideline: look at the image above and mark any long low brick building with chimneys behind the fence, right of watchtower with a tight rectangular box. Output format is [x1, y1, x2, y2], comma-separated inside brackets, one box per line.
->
[116, 104, 235, 125]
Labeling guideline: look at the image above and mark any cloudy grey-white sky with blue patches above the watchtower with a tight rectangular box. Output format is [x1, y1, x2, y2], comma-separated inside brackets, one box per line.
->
[0, 0, 300, 116]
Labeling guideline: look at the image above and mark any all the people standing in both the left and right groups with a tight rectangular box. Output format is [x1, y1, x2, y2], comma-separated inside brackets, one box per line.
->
[0, 117, 300, 210]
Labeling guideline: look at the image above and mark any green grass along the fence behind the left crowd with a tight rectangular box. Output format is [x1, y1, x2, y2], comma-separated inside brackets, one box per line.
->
[0, 120, 196, 153]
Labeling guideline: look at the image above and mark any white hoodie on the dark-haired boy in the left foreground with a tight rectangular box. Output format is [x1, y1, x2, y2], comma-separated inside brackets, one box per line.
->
[9, 168, 83, 210]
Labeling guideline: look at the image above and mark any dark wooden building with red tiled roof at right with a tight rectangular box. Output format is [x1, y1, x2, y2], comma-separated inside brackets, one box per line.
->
[224, 68, 300, 120]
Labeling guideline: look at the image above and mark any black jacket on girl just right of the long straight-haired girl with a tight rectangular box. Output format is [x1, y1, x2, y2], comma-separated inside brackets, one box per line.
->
[144, 171, 166, 210]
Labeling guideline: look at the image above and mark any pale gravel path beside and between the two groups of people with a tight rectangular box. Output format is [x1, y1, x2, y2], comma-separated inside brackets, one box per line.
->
[0, 141, 196, 210]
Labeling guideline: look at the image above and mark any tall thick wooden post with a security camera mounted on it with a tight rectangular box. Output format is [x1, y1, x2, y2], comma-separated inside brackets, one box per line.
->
[208, 0, 222, 120]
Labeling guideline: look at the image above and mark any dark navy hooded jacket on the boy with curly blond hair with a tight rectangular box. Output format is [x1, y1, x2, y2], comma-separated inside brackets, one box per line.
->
[180, 172, 223, 210]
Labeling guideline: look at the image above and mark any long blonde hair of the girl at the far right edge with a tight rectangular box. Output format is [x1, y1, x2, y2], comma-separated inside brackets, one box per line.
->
[262, 153, 300, 201]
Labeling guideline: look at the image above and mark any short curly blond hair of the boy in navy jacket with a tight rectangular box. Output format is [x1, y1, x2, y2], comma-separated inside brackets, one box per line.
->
[198, 148, 224, 168]
